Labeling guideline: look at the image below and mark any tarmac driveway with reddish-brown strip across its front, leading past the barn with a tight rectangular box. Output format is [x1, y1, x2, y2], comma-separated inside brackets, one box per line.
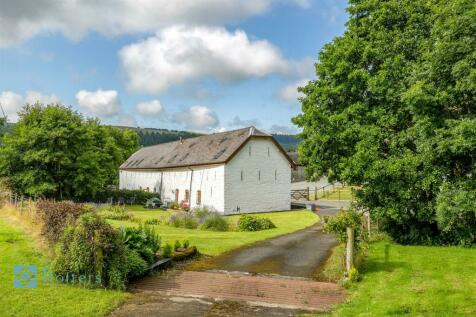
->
[112, 202, 345, 317]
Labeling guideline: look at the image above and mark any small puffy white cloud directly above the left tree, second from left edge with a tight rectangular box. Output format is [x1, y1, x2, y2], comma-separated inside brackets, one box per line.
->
[76, 89, 121, 117]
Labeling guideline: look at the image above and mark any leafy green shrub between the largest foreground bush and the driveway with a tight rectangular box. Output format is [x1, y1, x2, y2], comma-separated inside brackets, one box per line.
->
[120, 225, 160, 264]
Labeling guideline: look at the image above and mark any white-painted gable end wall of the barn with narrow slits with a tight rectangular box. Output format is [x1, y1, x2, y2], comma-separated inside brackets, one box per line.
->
[225, 138, 291, 214]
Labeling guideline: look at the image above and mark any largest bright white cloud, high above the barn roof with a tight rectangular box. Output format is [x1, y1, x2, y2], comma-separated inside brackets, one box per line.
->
[119, 26, 294, 93]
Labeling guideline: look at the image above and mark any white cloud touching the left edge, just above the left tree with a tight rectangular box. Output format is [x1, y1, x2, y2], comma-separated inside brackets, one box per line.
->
[0, 91, 59, 122]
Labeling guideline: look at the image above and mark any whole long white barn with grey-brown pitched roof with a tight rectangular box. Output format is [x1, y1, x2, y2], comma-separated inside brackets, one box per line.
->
[119, 127, 294, 214]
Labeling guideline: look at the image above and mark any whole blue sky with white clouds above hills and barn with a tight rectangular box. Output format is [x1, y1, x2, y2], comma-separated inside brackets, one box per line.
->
[0, 0, 348, 134]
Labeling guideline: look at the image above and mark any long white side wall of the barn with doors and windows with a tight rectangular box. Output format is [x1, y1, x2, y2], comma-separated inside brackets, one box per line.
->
[119, 164, 225, 212]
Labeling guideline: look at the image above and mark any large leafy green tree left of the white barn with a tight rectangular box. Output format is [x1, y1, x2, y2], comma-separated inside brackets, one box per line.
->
[0, 104, 139, 200]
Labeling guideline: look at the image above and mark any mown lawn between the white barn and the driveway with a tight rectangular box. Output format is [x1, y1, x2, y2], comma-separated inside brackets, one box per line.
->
[109, 207, 319, 255]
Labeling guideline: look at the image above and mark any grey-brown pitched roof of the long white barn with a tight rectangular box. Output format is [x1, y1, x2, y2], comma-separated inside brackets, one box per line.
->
[120, 127, 294, 170]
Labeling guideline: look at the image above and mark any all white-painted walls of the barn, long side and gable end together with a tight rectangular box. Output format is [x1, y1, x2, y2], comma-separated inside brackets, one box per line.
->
[119, 138, 291, 214]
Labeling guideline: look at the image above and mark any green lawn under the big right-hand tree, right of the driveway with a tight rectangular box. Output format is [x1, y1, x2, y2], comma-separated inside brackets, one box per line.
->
[324, 241, 476, 317]
